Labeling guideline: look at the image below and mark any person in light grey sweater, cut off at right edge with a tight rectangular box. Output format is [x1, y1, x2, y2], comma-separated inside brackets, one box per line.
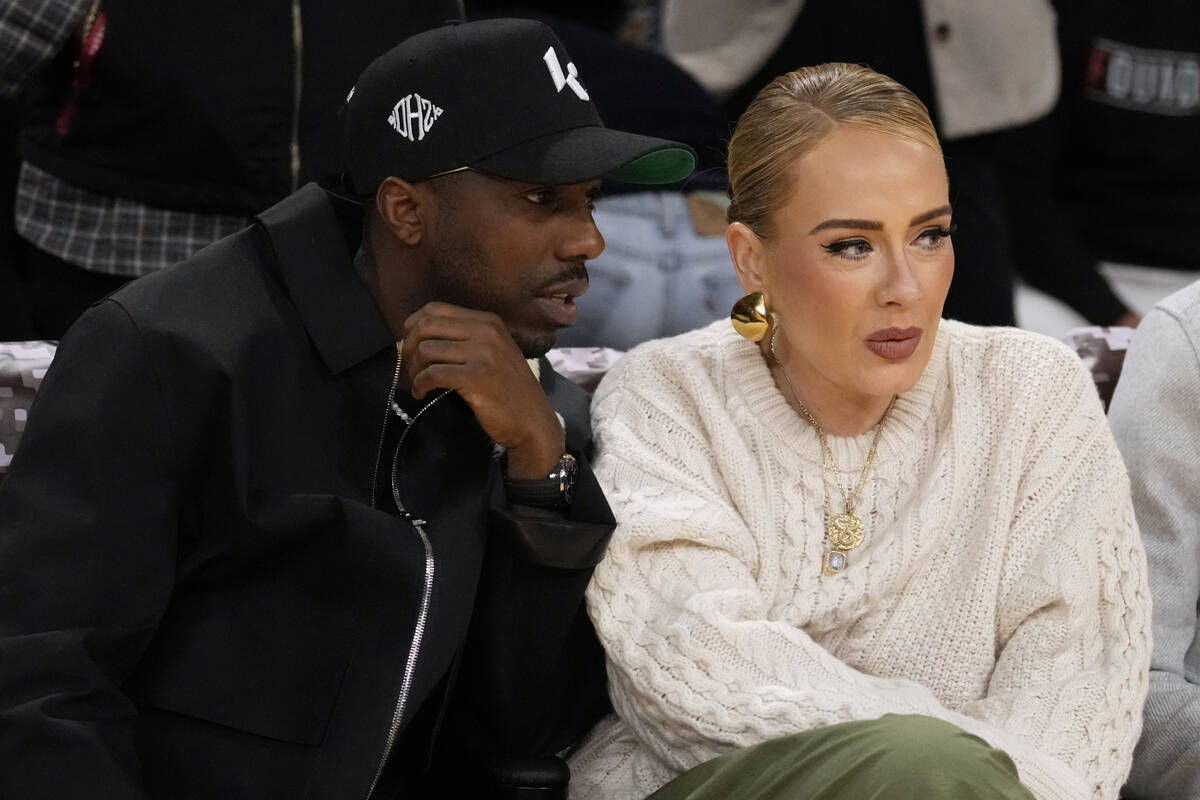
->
[1109, 309, 1200, 798]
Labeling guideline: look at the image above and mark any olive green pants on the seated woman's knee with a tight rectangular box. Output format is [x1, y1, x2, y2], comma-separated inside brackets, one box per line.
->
[648, 715, 1033, 800]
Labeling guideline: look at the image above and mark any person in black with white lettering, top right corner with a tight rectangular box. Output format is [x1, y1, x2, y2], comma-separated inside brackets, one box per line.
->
[996, 0, 1200, 336]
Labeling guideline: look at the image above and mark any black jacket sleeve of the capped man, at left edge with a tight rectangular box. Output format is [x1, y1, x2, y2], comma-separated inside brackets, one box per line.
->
[0, 301, 179, 800]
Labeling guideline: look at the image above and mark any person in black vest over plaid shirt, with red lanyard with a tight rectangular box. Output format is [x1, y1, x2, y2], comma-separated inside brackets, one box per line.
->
[0, 0, 461, 339]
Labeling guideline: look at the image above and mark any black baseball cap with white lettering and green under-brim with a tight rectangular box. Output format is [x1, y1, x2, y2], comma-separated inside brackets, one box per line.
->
[342, 19, 696, 196]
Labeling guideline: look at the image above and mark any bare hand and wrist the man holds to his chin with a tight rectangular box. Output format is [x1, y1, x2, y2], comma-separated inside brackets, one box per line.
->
[400, 302, 565, 480]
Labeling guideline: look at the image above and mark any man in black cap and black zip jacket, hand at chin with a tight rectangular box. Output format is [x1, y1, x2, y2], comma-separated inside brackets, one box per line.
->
[0, 20, 695, 800]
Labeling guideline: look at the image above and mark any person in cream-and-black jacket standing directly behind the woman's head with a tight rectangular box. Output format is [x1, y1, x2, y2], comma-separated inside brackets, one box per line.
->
[660, 0, 1058, 325]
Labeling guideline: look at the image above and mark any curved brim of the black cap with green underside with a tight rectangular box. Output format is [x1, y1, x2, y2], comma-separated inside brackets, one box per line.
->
[469, 126, 696, 185]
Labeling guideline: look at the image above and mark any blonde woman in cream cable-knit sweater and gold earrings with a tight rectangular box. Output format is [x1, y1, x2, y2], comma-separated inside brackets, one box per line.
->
[571, 64, 1148, 800]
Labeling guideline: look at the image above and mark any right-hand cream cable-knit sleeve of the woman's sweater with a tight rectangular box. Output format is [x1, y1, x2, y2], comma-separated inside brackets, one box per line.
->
[961, 345, 1150, 800]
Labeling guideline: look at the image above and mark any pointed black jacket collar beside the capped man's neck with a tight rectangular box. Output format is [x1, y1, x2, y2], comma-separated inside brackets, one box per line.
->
[256, 184, 395, 374]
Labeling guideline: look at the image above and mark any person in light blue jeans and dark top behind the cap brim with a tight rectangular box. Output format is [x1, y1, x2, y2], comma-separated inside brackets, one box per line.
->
[467, 1, 740, 350]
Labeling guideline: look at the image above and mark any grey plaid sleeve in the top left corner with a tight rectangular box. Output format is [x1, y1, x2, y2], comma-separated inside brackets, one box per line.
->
[0, 0, 88, 97]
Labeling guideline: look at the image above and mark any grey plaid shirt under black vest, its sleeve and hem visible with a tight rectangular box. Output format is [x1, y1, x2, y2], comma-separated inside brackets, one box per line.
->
[0, 0, 250, 277]
